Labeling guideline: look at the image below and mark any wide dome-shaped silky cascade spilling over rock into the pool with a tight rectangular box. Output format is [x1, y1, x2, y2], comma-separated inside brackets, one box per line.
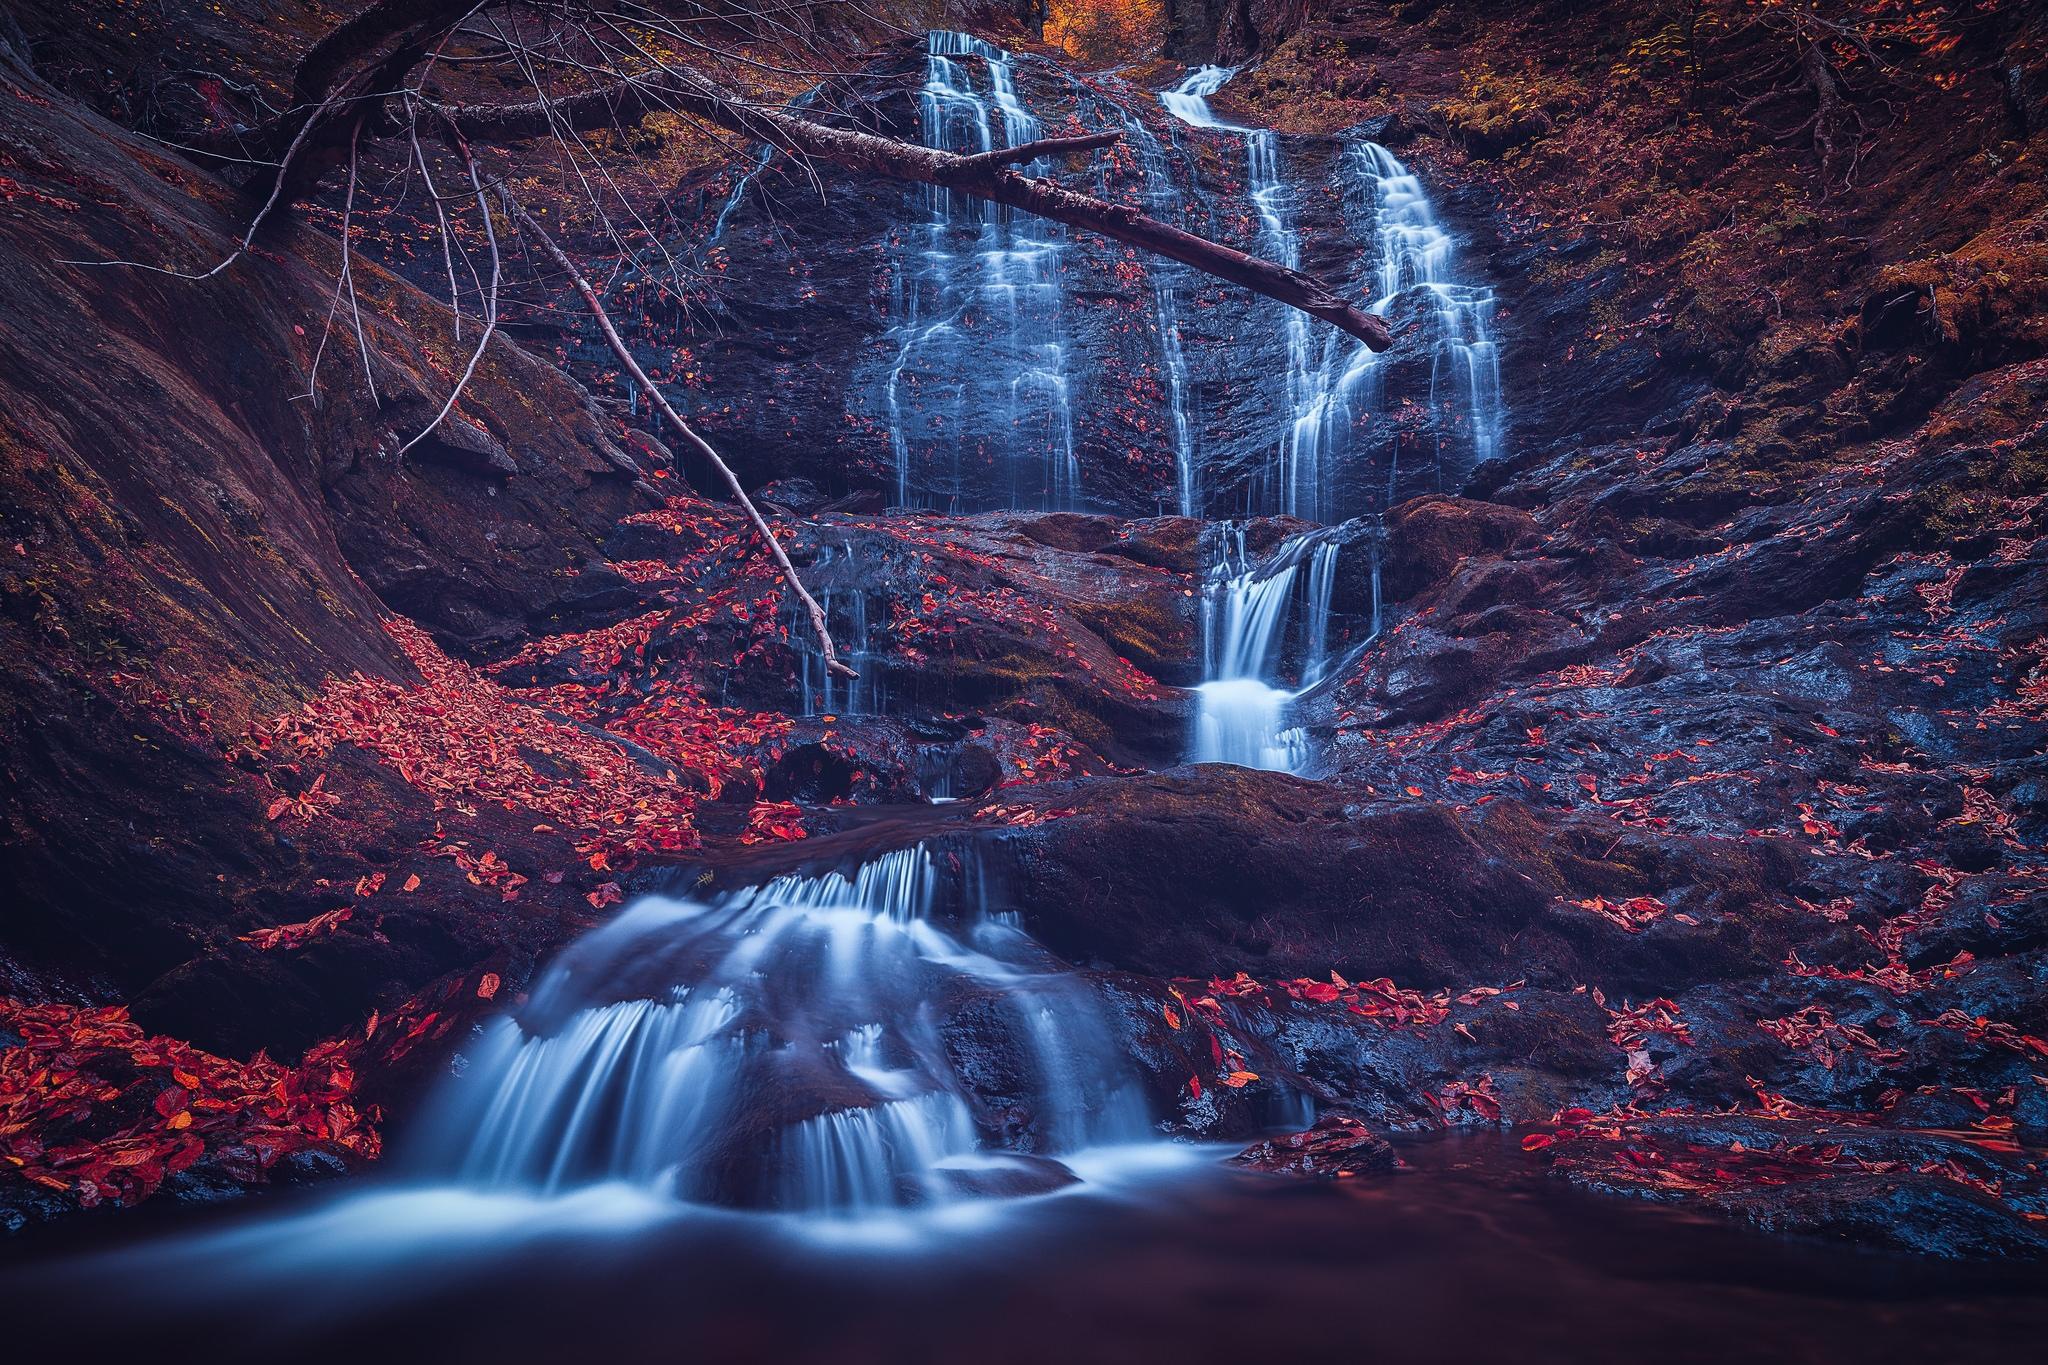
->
[420, 845, 1153, 1214]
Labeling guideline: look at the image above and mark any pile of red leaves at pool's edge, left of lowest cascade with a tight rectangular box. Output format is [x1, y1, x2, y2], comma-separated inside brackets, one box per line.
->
[0, 999, 381, 1207]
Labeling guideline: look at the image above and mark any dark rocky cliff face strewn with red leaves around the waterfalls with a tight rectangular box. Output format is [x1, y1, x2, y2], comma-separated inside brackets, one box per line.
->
[0, 2, 2048, 1252]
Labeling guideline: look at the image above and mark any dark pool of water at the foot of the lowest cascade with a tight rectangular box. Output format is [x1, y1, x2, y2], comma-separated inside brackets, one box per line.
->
[0, 1136, 2048, 1365]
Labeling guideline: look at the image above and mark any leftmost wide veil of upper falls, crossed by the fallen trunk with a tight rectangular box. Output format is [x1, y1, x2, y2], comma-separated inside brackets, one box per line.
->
[885, 31, 1081, 510]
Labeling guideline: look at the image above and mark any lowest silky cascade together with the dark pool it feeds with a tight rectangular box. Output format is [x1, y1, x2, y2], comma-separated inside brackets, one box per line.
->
[0, 847, 2048, 1365]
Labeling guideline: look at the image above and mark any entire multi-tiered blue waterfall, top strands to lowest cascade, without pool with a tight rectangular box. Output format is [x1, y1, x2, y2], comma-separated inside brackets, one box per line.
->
[331, 42, 1501, 1214]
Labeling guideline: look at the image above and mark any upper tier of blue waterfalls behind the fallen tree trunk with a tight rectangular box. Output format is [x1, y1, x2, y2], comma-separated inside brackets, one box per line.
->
[880, 43, 1505, 522]
